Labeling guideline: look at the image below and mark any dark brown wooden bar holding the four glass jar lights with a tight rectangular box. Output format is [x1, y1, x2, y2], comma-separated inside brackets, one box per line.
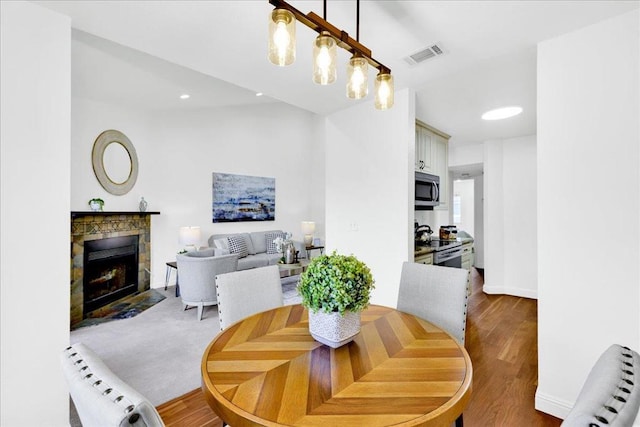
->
[269, 0, 391, 74]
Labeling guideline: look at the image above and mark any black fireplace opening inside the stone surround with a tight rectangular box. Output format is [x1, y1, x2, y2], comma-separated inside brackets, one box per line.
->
[82, 235, 138, 318]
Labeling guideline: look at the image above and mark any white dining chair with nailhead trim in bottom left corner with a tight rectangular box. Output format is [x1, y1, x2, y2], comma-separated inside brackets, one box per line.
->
[61, 343, 164, 427]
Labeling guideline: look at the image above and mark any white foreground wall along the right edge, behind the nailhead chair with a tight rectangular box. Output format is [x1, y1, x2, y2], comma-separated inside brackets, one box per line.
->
[536, 10, 640, 417]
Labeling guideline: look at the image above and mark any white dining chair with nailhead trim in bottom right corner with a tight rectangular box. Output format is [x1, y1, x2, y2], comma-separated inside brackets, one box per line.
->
[562, 344, 640, 427]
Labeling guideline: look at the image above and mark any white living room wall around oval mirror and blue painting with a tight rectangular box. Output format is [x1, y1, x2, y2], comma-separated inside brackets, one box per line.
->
[71, 98, 324, 287]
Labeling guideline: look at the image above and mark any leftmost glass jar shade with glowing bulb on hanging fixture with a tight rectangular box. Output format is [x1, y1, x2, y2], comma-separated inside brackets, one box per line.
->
[269, 9, 296, 67]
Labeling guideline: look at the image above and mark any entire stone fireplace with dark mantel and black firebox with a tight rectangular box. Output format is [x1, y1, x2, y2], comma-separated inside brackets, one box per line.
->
[69, 211, 160, 329]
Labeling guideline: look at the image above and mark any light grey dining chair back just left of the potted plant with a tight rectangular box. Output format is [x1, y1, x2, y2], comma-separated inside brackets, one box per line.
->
[216, 265, 283, 331]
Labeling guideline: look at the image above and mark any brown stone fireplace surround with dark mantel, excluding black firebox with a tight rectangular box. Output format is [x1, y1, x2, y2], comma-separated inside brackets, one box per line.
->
[70, 211, 160, 326]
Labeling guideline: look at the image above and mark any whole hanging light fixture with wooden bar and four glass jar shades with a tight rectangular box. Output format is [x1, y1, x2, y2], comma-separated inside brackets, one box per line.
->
[268, 0, 394, 110]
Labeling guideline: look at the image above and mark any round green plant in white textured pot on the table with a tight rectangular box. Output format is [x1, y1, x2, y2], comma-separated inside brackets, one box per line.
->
[298, 251, 374, 348]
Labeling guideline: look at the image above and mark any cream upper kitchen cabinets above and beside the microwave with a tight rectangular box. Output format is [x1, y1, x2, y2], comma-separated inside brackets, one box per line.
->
[415, 120, 450, 210]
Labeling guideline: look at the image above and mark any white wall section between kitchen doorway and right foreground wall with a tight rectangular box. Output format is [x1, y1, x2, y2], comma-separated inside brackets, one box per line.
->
[483, 136, 538, 298]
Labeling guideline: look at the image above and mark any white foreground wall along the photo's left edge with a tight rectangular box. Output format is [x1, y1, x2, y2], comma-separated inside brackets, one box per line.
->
[0, 1, 71, 427]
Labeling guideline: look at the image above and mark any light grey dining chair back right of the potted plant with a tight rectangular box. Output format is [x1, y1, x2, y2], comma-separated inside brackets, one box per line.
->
[398, 262, 469, 344]
